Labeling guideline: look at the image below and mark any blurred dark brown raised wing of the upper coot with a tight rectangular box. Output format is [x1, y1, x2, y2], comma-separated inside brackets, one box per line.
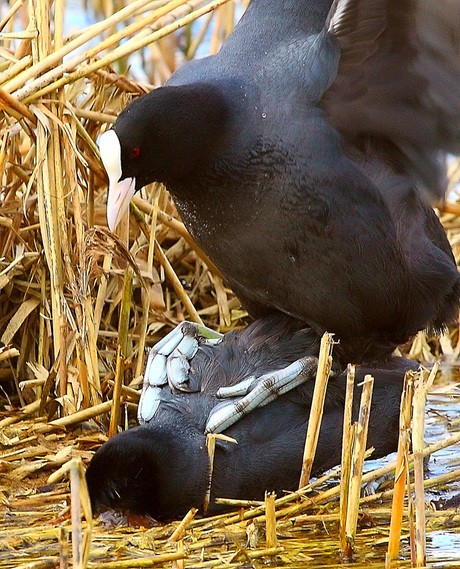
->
[321, 0, 460, 201]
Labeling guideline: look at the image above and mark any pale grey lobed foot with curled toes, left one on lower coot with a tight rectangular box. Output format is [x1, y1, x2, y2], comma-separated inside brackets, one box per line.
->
[137, 322, 223, 423]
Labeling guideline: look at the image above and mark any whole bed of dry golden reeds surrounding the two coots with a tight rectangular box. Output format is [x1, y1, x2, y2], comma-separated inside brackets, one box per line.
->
[0, 0, 460, 569]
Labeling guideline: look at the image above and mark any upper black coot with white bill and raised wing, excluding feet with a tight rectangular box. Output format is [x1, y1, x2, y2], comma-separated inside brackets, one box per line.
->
[101, 0, 460, 362]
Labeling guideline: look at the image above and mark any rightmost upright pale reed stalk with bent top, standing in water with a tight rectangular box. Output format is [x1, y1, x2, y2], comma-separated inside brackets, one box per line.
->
[412, 362, 439, 567]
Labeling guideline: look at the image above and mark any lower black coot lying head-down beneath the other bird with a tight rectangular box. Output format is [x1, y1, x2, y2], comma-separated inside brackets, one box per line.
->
[86, 314, 415, 519]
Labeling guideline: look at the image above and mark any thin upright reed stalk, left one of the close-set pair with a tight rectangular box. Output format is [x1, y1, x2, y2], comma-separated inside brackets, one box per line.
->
[340, 365, 355, 551]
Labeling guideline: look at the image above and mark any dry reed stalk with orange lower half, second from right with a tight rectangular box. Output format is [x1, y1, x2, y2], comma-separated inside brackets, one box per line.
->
[385, 372, 414, 567]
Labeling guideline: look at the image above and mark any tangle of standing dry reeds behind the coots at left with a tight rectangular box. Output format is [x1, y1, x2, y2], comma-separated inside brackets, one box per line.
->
[0, 0, 248, 420]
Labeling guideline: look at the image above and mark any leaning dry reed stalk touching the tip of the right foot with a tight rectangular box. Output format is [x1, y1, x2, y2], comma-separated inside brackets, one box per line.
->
[299, 332, 334, 488]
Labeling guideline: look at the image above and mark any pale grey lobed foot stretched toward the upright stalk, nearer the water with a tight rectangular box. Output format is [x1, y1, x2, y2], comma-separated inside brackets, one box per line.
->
[206, 356, 318, 433]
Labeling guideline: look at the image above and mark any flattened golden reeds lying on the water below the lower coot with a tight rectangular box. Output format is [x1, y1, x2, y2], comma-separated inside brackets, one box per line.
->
[0, 392, 460, 569]
